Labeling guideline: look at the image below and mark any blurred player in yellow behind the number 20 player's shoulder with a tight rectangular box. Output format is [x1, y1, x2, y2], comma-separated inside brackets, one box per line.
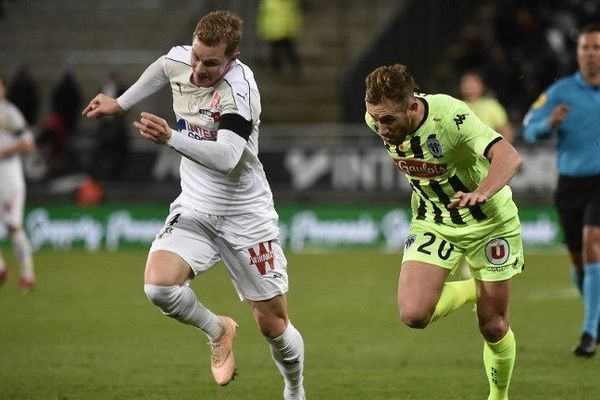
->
[460, 71, 514, 143]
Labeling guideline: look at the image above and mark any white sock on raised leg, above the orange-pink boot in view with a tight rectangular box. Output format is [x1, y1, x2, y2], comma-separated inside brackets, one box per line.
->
[144, 284, 222, 339]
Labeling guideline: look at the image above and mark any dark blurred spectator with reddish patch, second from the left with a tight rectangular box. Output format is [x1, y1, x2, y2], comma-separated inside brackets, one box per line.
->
[38, 70, 82, 175]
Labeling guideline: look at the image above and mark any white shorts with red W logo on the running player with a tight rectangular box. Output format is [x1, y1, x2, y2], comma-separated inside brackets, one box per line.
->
[150, 203, 288, 301]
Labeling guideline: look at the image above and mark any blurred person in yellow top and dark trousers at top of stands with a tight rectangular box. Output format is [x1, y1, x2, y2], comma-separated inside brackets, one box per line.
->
[257, 0, 303, 74]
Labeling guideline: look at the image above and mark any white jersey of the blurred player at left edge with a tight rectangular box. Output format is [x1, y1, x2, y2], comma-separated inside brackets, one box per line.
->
[0, 100, 31, 202]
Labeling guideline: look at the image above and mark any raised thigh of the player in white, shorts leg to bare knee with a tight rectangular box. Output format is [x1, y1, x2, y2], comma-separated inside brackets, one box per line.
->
[145, 205, 220, 284]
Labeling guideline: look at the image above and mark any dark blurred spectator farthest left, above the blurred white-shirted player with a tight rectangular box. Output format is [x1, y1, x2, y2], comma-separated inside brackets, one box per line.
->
[6, 65, 40, 127]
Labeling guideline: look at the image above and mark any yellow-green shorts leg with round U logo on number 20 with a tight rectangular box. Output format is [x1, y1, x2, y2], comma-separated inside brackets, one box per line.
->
[465, 216, 525, 282]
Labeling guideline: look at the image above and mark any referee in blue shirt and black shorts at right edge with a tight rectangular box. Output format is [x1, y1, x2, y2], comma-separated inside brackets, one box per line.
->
[523, 24, 600, 357]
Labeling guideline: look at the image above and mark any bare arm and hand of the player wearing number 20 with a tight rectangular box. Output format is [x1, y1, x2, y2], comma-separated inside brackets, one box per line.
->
[448, 140, 522, 209]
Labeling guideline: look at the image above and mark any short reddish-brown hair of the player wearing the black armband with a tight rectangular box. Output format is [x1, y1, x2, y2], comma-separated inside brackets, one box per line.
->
[193, 11, 244, 56]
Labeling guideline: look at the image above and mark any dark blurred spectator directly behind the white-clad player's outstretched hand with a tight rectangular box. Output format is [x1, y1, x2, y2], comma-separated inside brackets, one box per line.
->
[94, 71, 129, 179]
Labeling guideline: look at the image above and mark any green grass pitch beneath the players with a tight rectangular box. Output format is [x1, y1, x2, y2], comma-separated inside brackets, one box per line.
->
[0, 249, 600, 400]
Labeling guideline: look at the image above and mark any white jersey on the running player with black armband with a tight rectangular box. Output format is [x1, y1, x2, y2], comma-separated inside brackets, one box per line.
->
[164, 46, 273, 215]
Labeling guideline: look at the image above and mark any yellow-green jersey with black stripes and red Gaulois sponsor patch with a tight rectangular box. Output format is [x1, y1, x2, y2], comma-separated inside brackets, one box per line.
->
[365, 94, 517, 226]
